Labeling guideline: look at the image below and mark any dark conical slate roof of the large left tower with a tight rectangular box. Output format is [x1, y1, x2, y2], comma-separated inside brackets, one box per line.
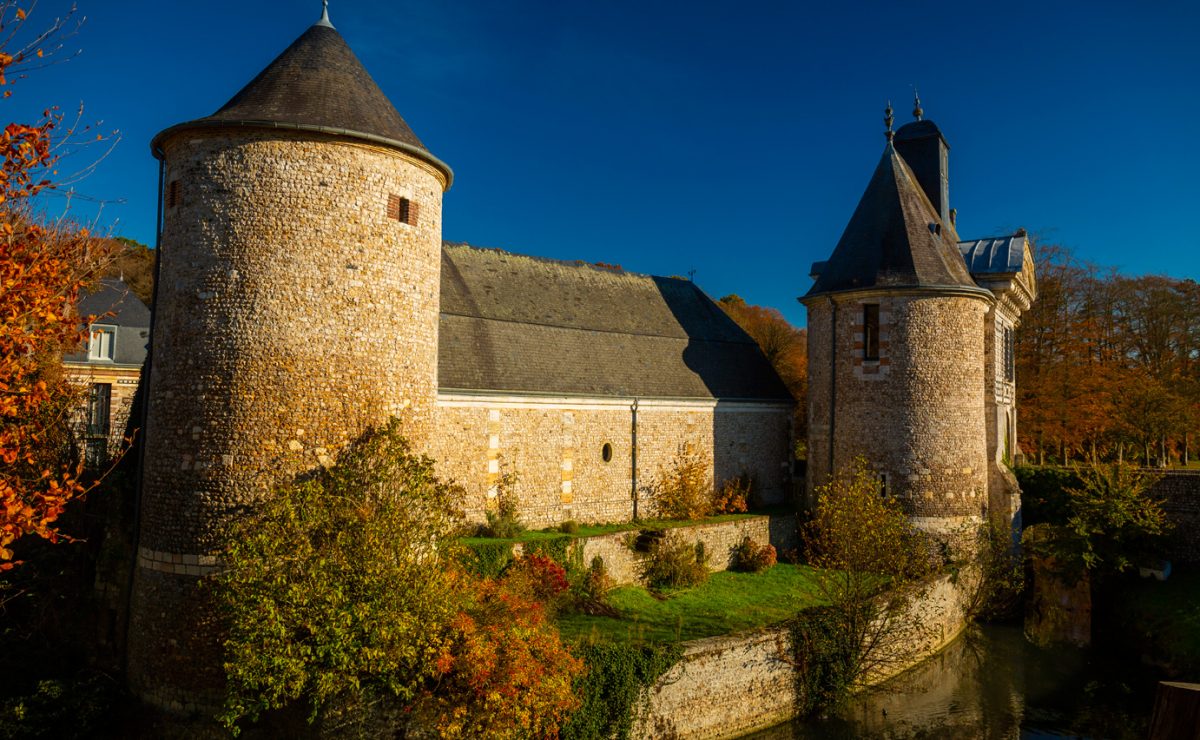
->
[151, 19, 451, 184]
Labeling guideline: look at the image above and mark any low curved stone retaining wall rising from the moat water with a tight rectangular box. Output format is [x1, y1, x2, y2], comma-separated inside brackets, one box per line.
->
[634, 574, 970, 739]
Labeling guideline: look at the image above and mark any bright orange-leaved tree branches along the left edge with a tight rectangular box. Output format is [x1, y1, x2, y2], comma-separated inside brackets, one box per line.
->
[0, 1, 108, 570]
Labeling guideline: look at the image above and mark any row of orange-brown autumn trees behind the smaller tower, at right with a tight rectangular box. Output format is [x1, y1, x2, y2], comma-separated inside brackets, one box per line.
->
[1016, 239, 1200, 465]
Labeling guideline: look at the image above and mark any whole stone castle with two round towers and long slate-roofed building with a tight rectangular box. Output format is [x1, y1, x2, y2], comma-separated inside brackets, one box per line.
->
[128, 5, 1033, 709]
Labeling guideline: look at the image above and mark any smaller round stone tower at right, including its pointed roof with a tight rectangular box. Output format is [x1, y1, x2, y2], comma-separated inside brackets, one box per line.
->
[800, 108, 994, 535]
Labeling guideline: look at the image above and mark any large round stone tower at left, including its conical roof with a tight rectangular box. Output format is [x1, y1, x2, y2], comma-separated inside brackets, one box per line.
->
[128, 5, 452, 709]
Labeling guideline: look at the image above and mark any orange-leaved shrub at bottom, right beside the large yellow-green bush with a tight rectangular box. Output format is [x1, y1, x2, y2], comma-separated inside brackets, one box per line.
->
[414, 579, 583, 738]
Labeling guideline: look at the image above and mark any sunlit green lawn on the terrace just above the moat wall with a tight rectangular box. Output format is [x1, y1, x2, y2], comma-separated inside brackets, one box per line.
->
[558, 562, 820, 643]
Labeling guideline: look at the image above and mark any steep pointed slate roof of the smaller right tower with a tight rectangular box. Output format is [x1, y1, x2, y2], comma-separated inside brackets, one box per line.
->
[804, 144, 985, 299]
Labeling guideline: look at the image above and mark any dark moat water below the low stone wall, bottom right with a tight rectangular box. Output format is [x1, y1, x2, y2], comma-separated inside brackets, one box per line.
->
[749, 625, 1162, 740]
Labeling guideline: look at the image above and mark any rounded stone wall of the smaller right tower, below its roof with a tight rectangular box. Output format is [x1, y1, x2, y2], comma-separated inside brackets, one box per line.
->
[808, 290, 989, 533]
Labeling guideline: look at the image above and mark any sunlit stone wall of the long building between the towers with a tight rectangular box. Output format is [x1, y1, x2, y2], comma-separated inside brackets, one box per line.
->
[430, 393, 791, 527]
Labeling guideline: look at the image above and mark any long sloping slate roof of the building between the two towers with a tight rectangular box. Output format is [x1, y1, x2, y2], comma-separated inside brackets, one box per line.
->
[438, 243, 792, 402]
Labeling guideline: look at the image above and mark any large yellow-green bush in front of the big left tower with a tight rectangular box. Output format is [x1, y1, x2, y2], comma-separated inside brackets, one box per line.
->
[214, 420, 462, 733]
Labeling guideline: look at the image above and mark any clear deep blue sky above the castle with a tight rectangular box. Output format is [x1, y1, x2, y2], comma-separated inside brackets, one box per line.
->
[11, 0, 1200, 324]
